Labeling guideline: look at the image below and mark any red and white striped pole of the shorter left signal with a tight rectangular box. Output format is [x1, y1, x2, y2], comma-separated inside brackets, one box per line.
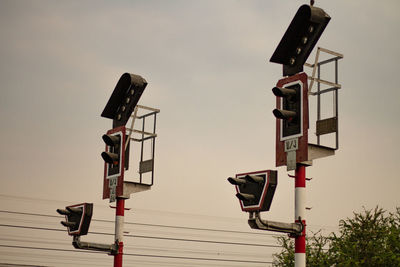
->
[114, 198, 125, 267]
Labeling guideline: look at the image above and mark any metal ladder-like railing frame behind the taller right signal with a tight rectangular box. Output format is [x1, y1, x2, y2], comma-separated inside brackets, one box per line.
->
[304, 47, 343, 150]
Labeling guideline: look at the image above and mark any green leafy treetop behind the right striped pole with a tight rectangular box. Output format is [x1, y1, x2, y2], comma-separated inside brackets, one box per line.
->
[273, 207, 400, 267]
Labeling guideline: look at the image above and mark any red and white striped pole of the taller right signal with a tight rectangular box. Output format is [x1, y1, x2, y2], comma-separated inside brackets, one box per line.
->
[294, 164, 306, 267]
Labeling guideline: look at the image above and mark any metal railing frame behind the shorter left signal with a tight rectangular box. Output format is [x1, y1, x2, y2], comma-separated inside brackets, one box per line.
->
[125, 105, 160, 186]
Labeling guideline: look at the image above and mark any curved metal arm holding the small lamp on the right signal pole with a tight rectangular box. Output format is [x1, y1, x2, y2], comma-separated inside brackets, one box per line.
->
[248, 212, 304, 236]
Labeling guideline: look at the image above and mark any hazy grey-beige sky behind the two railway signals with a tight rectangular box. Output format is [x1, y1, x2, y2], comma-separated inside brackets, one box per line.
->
[0, 0, 400, 266]
